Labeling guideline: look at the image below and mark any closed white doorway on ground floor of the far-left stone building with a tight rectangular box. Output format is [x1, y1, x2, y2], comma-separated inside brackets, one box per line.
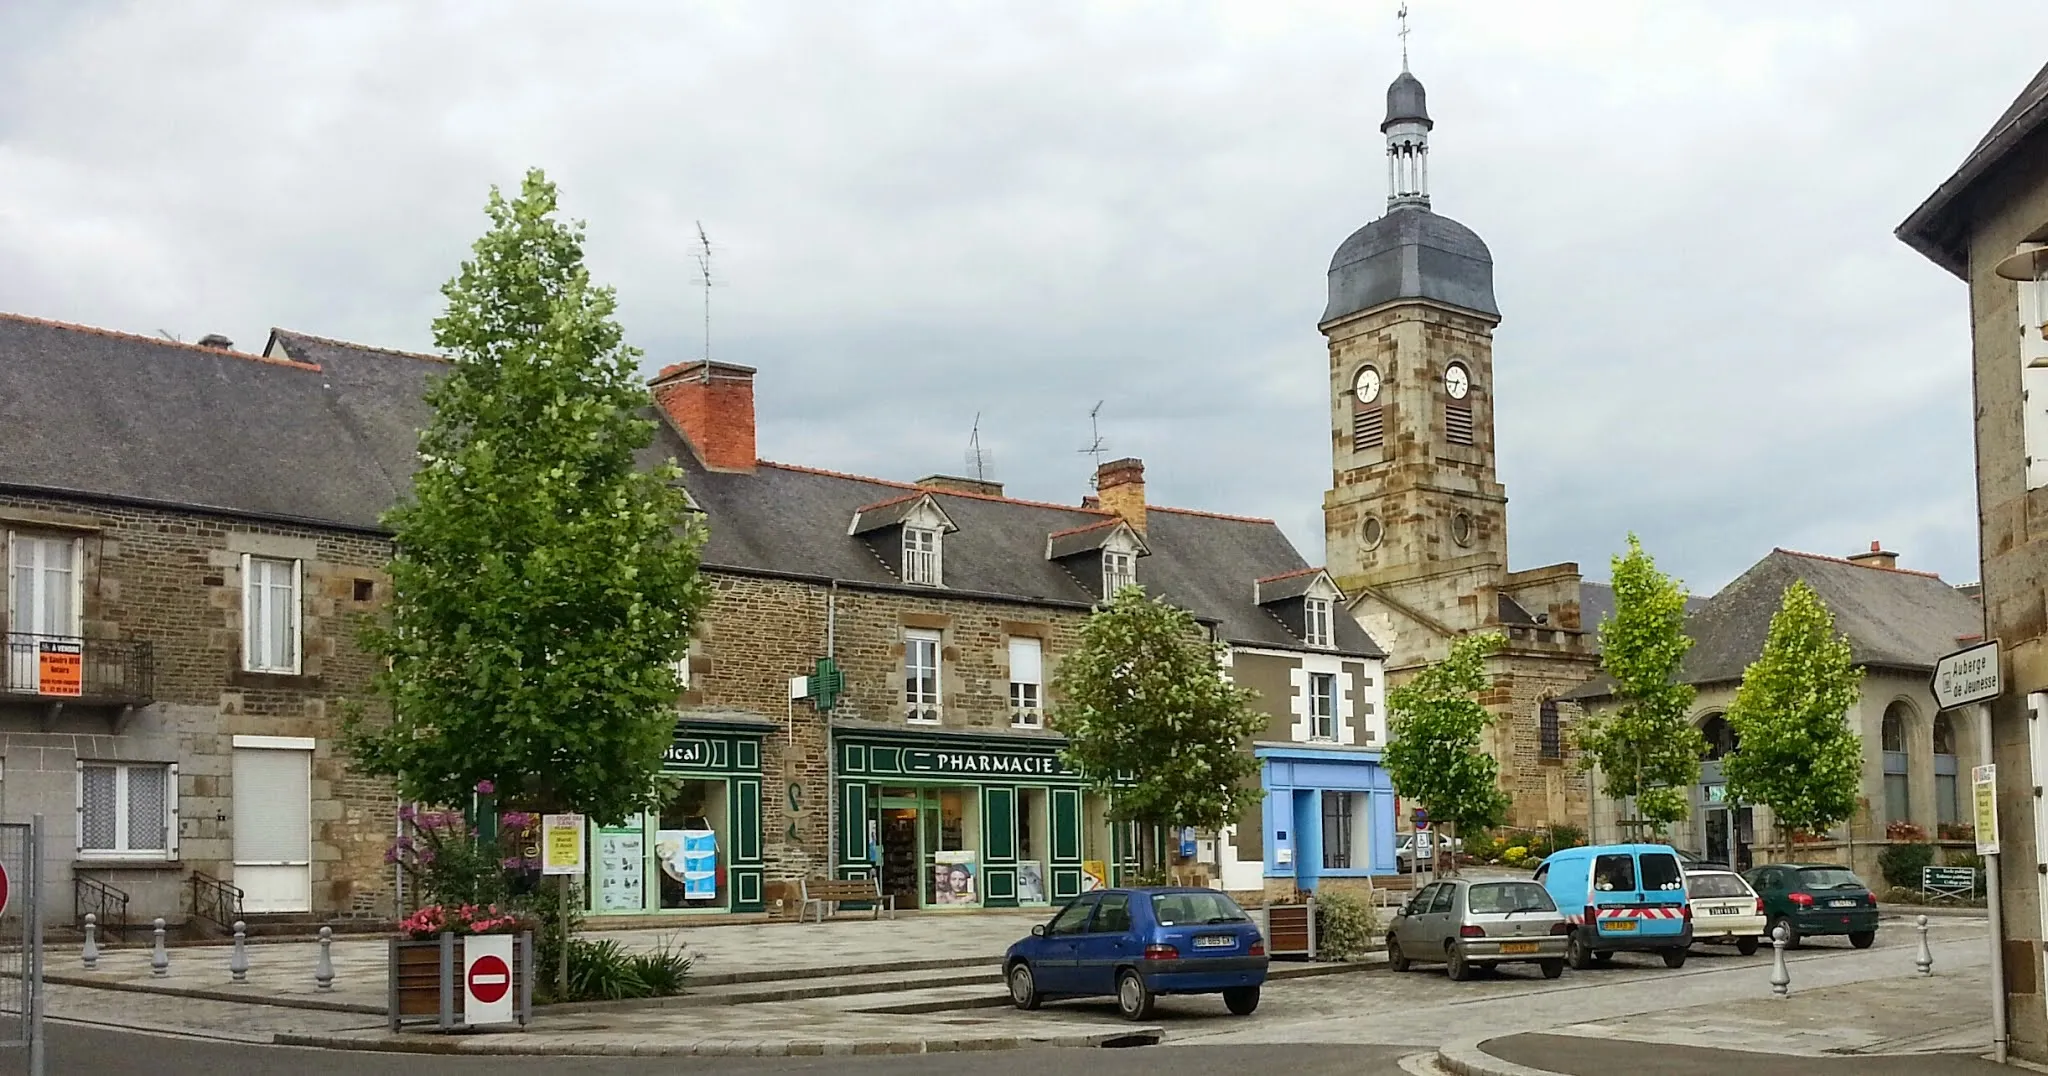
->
[233, 748, 313, 912]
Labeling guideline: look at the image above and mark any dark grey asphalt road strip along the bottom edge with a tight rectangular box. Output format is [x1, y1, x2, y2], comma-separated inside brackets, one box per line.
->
[0, 1023, 1415, 1076]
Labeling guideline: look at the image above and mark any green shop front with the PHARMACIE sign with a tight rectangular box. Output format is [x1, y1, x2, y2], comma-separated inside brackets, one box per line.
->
[834, 730, 1137, 910]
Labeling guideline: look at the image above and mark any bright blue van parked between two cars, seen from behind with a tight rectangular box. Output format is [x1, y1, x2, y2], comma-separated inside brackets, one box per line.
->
[1536, 844, 1692, 971]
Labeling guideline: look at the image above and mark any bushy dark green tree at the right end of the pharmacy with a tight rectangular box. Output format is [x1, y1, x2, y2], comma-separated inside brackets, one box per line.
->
[1053, 586, 1266, 873]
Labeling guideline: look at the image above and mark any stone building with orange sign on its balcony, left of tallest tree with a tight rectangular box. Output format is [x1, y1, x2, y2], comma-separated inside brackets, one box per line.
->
[0, 316, 438, 922]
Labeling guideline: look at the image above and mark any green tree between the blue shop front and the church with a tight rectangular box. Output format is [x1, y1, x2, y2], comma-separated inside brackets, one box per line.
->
[1380, 631, 1507, 863]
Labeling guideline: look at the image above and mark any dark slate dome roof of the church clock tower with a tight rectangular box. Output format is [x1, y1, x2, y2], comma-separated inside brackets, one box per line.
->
[1323, 205, 1501, 322]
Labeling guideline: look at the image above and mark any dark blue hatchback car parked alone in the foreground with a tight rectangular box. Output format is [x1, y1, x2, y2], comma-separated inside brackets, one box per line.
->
[1004, 887, 1266, 1021]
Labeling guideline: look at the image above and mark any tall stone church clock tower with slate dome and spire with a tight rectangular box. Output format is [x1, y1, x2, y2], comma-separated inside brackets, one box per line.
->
[1317, 60, 1597, 826]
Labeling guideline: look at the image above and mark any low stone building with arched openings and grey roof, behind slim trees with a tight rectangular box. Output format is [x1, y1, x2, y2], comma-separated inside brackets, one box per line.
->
[1567, 543, 1982, 883]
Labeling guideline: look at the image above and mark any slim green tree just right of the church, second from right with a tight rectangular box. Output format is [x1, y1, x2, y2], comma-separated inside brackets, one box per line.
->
[1577, 535, 1706, 830]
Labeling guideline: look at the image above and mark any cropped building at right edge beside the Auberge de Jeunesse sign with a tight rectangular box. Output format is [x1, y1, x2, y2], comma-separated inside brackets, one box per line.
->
[1898, 56, 2048, 1062]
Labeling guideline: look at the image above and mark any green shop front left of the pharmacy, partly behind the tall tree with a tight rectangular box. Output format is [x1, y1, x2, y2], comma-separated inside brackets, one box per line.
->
[586, 721, 776, 916]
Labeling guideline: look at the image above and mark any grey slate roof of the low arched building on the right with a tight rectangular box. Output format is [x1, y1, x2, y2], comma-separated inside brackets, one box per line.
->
[1567, 549, 1985, 699]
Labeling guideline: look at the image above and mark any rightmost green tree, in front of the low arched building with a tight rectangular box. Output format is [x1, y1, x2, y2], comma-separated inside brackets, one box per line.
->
[1720, 580, 1864, 859]
